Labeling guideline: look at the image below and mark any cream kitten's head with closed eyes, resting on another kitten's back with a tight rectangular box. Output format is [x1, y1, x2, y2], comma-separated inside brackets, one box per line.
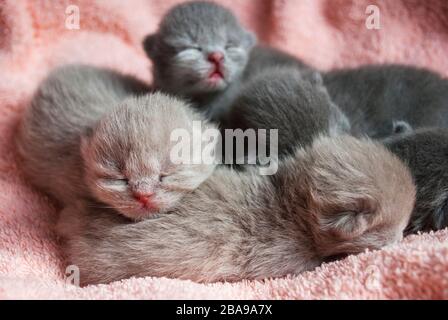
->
[81, 93, 214, 219]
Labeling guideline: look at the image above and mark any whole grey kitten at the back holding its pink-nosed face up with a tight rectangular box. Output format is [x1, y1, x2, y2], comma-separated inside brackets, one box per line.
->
[143, 1, 312, 120]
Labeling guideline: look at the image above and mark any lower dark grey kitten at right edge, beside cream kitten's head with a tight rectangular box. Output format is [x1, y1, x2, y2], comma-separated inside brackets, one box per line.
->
[385, 129, 448, 234]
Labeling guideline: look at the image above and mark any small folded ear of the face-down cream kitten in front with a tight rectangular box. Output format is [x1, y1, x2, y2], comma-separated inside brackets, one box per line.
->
[320, 197, 379, 239]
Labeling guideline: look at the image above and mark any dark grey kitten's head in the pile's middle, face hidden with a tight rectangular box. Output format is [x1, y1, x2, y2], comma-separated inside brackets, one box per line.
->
[222, 67, 350, 160]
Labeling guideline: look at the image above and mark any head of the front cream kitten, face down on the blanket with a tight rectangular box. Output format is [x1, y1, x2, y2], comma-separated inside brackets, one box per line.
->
[284, 136, 415, 258]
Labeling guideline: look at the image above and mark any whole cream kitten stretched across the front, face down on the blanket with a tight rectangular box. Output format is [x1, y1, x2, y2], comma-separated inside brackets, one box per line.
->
[58, 136, 415, 285]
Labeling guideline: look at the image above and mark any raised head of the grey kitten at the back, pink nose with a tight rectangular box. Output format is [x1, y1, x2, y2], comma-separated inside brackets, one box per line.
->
[143, 1, 256, 95]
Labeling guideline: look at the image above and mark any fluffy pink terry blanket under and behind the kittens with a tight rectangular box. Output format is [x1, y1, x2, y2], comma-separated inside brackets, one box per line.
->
[0, 0, 448, 299]
